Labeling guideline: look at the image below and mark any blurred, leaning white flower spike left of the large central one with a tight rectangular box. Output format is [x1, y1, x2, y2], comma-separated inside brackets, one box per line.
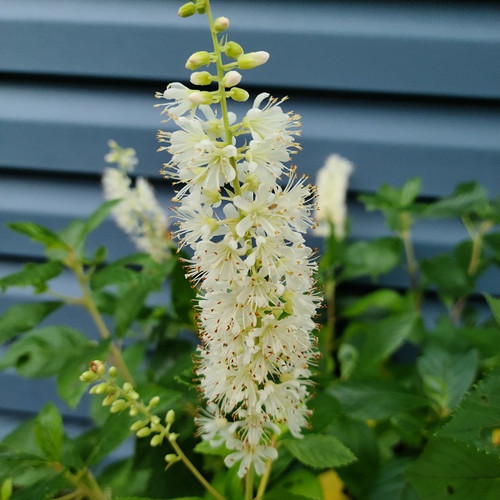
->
[102, 141, 172, 262]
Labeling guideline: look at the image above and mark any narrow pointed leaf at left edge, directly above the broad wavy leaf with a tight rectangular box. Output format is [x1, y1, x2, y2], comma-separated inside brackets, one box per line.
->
[0, 301, 63, 342]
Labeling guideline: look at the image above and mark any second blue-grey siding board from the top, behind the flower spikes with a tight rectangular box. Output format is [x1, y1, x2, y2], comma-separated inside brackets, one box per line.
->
[0, 83, 500, 196]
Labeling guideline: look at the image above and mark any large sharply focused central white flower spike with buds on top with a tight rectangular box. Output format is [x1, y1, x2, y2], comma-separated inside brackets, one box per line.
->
[157, 2, 320, 477]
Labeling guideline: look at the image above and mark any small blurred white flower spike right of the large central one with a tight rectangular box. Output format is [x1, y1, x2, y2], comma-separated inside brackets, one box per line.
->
[315, 155, 353, 240]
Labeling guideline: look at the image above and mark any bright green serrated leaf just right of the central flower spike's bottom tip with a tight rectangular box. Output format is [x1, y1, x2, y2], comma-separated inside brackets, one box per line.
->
[280, 434, 356, 469]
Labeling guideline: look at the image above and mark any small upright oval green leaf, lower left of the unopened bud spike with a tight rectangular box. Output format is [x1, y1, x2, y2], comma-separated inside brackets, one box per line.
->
[35, 403, 64, 462]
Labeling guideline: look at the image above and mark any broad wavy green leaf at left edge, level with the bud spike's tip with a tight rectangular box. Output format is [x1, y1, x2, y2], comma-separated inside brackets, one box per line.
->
[0, 326, 91, 377]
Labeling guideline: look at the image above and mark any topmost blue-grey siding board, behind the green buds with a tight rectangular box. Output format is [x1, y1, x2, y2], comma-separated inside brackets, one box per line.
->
[0, 0, 500, 98]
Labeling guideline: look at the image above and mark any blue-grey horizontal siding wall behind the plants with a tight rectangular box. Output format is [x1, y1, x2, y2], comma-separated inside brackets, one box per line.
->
[0, 0, 500, 434]
